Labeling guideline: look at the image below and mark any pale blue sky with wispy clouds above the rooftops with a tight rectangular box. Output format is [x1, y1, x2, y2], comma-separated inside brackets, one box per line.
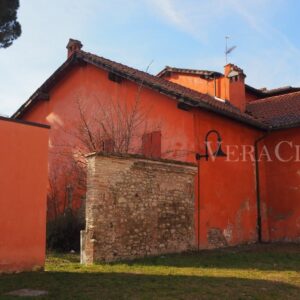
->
[0, 0, 300, 116]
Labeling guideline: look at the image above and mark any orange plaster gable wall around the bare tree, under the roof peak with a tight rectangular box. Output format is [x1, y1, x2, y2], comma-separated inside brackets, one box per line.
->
[23, 65, 194, 217]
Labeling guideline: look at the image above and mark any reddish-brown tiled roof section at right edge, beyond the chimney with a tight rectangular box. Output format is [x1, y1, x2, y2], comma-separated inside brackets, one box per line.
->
[246, 92, 300, 129]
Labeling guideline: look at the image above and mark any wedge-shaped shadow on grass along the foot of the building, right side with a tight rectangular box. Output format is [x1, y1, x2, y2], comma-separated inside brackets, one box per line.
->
[118, 243, 300, 270]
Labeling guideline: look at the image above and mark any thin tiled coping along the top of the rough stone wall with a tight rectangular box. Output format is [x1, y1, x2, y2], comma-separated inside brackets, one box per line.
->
[85, 152, 197, 168]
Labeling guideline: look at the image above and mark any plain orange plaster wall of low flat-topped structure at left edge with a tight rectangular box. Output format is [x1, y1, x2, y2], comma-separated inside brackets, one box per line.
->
[0, 119, 49, 273]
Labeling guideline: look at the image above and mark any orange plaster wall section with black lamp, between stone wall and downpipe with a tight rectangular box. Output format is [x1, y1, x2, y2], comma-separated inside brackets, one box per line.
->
[195, 111, 259, 248]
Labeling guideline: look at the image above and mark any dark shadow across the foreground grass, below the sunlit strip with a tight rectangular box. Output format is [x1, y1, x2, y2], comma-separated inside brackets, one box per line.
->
[0, 272, 300, 300]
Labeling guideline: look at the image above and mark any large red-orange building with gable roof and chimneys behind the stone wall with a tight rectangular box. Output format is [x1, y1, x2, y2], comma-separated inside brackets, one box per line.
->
[13, 40, 300, 248]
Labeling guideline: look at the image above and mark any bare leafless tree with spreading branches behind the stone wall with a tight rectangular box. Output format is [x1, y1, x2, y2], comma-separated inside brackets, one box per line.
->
[48, 86, 160, 219]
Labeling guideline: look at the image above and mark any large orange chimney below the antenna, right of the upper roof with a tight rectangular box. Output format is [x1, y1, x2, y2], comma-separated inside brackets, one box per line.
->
[224, 64, 246, 112]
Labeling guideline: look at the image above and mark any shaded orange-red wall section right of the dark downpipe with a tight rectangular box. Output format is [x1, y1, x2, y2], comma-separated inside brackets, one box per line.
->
[265, 128, 300, 241]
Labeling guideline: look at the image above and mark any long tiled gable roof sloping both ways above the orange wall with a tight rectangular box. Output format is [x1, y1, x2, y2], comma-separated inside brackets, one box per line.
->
[12, 51, 265, 129]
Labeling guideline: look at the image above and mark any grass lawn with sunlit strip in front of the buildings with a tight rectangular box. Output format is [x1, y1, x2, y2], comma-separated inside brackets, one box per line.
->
[0, 244, 300, 300]
